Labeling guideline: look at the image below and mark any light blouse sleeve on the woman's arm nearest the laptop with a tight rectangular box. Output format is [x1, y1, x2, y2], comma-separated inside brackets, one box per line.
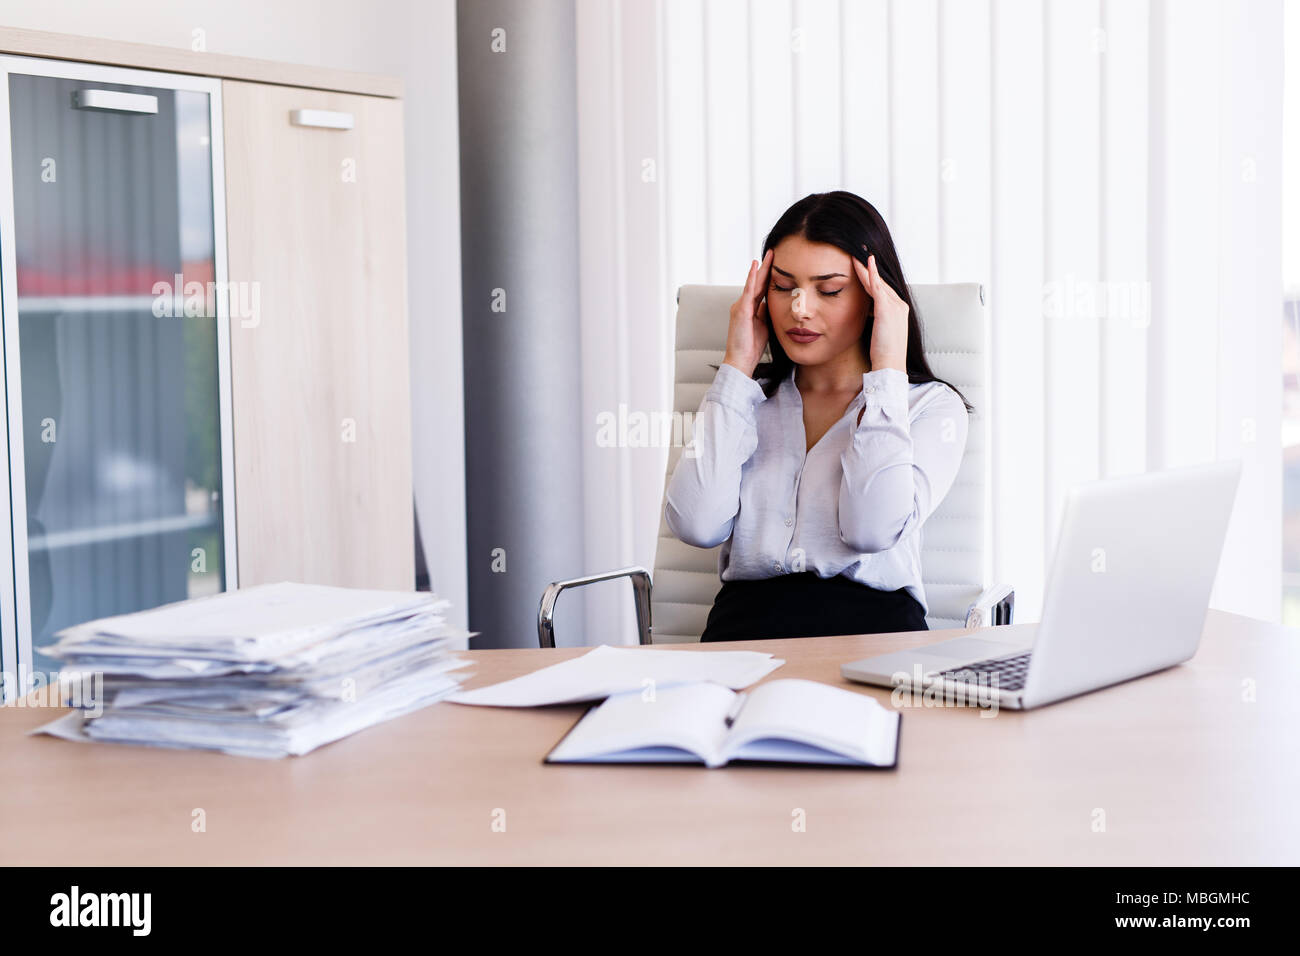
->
[840, 368, 969, 554]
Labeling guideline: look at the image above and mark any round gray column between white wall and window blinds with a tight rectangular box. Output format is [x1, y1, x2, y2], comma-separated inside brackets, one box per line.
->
[452, 0, 589, 648]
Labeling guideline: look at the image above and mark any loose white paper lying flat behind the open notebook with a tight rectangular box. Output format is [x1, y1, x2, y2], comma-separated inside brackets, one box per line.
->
[446, 644, 785, 708]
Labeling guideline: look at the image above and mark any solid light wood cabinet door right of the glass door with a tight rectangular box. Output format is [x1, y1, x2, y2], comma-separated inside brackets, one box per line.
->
[222, 81, 415, 589]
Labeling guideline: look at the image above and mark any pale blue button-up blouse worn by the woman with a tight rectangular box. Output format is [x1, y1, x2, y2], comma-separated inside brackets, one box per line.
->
[664, 363, 967, 614]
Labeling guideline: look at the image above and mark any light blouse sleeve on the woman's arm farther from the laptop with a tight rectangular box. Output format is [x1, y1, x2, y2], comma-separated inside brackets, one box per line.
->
[664, 363, 767, 548]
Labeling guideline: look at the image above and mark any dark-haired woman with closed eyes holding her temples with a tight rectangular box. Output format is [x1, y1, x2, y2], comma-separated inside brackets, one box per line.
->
[664, 191, 971, 641]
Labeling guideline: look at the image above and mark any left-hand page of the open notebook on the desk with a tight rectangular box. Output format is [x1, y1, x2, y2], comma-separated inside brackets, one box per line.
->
[547, 682, 736, 766]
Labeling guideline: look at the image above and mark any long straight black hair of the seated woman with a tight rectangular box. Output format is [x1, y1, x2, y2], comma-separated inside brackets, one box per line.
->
[722, 190, 975, 412]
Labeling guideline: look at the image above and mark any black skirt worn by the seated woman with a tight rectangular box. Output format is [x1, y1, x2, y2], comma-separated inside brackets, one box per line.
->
[699, 571, 930, 643]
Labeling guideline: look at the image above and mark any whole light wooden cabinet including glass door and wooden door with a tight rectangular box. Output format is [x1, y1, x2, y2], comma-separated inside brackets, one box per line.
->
[0, 27, 415, 698]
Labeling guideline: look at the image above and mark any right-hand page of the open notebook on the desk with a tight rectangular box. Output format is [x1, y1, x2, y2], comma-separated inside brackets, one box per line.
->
[723, 678, 898, 766]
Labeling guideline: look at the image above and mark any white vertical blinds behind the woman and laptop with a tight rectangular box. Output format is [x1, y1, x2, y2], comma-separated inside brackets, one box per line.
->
[577, 0, 1282, 640]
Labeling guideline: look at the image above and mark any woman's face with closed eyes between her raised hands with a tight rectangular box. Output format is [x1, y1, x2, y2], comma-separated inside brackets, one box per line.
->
[767, 235, 871, 365]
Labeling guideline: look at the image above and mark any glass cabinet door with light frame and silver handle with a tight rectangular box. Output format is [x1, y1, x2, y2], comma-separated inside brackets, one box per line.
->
[0, 57, 237, 691]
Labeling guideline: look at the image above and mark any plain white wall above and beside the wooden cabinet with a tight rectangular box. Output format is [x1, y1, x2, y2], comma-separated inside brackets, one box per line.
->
[0, 0, 467, 639]
